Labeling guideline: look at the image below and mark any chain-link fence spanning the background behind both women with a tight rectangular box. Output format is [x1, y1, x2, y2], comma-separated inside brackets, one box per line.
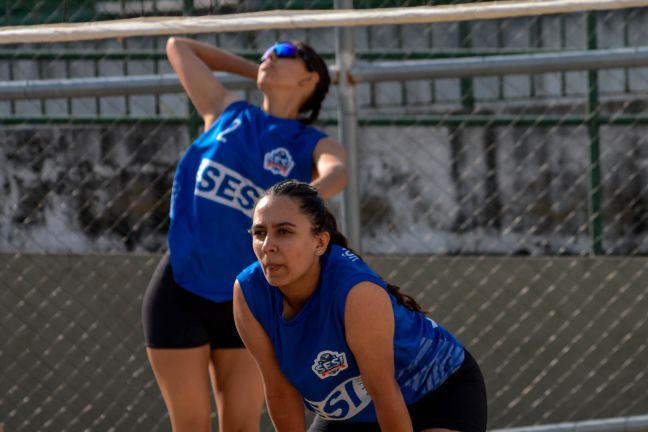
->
[0, 0, 648, 432]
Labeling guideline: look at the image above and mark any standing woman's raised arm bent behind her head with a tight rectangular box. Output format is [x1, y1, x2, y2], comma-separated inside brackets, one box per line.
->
[166, 37, 258, 130]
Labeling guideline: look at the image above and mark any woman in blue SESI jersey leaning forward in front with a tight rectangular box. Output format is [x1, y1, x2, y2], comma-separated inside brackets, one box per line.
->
[234, 180, 486, 432]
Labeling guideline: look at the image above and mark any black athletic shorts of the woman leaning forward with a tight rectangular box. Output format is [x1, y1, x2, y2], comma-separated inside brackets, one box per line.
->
[308, 351, 486, 432]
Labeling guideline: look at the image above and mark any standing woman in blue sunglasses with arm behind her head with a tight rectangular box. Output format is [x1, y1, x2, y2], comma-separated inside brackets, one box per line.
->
[142, 37, 346, 432]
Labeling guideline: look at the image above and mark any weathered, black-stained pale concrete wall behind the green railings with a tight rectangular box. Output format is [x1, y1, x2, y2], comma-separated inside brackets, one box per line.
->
[0, 9, 648, 255]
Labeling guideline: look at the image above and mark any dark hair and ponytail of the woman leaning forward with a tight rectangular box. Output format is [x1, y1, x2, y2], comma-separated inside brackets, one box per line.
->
[265, 180, 427, 314]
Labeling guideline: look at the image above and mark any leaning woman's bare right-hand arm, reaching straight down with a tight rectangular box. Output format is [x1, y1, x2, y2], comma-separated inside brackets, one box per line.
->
[344, 282, 413, 432]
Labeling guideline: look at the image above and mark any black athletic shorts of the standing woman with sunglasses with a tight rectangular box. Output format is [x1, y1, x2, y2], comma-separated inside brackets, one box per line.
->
[142, 255, 244, 349]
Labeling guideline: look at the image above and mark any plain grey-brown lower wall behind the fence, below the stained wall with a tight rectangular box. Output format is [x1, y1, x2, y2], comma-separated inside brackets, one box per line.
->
[0, 253, 648, 432]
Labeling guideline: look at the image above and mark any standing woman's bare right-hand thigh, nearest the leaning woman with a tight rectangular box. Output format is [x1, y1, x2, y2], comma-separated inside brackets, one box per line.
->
[210, 348, 263, 431]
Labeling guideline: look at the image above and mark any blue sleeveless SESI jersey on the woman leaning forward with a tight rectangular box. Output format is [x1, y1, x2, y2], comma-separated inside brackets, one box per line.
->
[238, 246, 464, 422]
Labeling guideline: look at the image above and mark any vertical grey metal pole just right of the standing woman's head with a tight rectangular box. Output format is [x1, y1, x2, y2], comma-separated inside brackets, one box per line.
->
[335, 0, 362, 252]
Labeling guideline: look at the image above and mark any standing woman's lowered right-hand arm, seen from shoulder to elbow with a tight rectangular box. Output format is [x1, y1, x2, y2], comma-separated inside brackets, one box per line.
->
[311, 138, 347, 198]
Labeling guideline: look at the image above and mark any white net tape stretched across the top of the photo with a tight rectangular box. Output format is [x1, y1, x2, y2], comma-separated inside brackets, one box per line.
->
[0, 0, 648, 44]
